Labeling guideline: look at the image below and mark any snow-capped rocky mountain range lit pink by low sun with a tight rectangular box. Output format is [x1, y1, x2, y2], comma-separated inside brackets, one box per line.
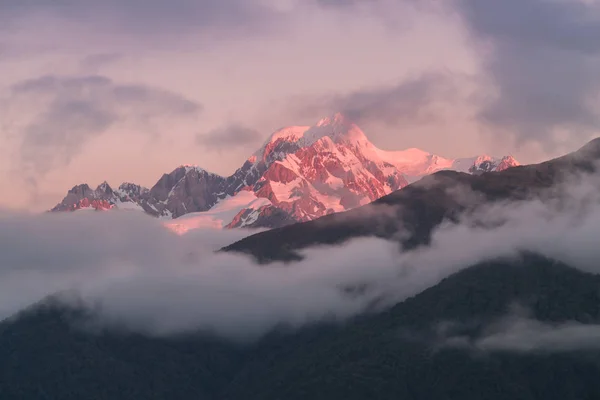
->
[52, 114, 518, 233]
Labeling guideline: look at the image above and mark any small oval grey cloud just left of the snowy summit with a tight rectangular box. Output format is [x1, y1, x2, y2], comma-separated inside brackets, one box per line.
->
[196, 124, 262, 150]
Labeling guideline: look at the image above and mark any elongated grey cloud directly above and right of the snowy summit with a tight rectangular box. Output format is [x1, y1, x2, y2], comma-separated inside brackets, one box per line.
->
[292, 73, 459, 127]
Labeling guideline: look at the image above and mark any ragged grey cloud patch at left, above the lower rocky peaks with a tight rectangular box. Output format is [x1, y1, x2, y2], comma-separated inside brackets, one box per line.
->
[9, 76, 202, 175]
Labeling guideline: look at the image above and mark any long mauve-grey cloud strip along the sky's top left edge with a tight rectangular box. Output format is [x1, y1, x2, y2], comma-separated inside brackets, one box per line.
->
[0, 0, 278, 35]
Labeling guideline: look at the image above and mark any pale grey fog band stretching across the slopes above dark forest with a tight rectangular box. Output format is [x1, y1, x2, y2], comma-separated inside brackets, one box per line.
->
[0, 171, 600, 340]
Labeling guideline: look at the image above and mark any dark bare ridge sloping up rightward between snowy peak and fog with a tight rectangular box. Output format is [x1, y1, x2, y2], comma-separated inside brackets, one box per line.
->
[223, 138, 600, 262]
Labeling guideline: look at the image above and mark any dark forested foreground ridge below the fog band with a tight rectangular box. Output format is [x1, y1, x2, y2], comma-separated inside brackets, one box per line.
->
[0, 255, 600, 400]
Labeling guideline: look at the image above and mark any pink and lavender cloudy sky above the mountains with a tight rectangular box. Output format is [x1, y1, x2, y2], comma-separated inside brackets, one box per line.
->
[0, 0, 600, 210]
